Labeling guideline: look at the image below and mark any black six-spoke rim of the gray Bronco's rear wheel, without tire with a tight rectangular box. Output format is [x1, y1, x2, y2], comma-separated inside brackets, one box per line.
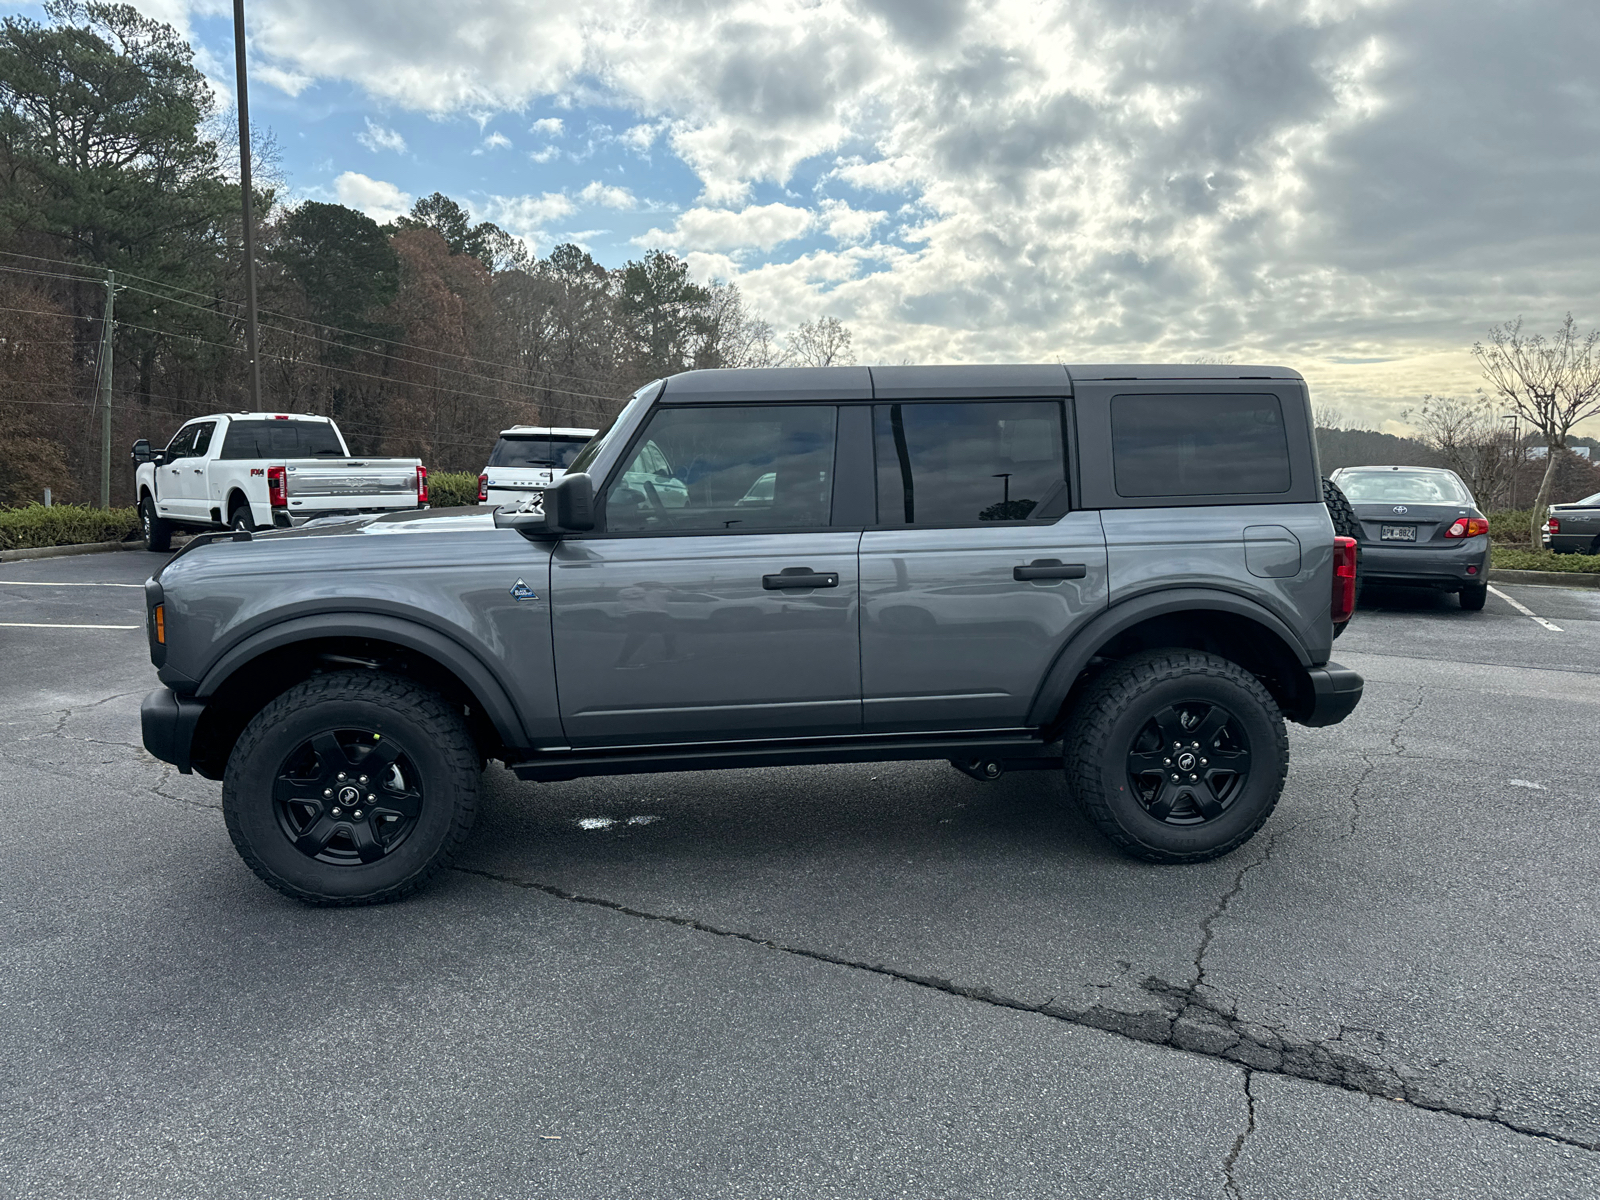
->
[1128, 702, 1250, 826]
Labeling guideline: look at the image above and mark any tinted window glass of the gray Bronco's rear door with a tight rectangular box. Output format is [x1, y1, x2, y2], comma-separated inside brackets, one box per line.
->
[872, 400, 1066, 525]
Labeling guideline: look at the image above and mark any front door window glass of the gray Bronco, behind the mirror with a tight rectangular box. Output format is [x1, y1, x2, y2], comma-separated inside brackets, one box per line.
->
[605, 405, 835, 533]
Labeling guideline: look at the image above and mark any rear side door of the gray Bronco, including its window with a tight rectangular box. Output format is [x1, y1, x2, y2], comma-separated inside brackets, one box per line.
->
[861, 398, 1106, 731]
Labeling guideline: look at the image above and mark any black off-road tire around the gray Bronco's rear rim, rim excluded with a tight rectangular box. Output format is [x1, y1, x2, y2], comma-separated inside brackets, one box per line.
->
[1064, 650, 1290, 862]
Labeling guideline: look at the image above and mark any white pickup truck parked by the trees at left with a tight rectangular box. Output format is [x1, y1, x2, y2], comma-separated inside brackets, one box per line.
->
[133, 413, 427, 550]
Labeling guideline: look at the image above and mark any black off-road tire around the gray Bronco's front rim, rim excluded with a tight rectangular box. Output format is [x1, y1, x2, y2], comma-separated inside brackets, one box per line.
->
[222, 670, 482, 906]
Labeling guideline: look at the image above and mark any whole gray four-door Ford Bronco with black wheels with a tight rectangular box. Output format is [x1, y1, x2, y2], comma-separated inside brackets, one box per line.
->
[142, 366, 1362, 904]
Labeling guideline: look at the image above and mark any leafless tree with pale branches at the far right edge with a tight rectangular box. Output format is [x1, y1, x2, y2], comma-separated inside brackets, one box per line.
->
[1472, 312, 1600, 546]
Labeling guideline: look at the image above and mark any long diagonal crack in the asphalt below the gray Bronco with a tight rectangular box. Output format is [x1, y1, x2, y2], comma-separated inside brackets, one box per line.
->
[451, 856, 1600, 1160]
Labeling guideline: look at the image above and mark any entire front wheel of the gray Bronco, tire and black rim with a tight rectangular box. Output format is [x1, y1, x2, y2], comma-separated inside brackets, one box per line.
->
[222, 672, 478, 904]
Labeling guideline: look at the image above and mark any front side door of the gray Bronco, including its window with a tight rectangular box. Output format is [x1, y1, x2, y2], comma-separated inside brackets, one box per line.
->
[550, 403, 861, 746]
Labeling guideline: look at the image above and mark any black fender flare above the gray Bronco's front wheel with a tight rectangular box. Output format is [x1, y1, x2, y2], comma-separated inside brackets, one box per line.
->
[194, 613, 531, 746]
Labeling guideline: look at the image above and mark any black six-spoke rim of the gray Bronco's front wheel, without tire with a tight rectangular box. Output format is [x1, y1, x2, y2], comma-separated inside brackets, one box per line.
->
[272, 730, 424, 866]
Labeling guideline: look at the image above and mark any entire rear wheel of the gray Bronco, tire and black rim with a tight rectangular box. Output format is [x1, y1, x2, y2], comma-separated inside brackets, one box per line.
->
[1066, 650, 1290, 862]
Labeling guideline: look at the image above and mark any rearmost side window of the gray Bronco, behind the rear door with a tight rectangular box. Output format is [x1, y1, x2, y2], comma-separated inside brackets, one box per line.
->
[1110, 395, 1290, 496]
